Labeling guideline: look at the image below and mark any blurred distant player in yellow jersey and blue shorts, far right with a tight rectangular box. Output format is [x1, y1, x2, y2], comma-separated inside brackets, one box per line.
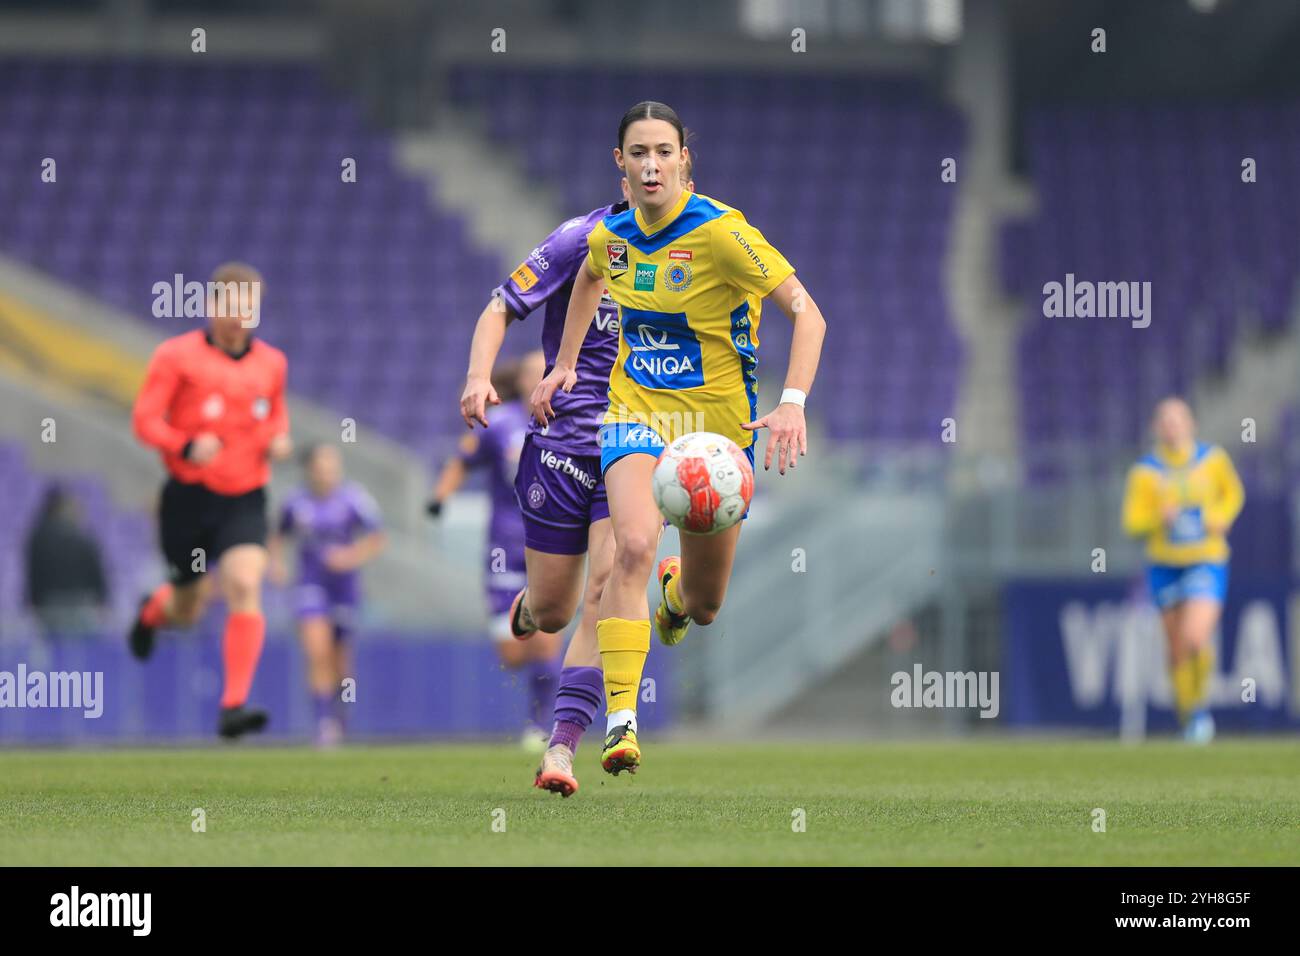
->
[1123, 398, 1245, 743]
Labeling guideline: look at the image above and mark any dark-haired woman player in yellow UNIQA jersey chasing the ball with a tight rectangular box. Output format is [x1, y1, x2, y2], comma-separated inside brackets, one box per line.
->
[532, 101, 826, 774]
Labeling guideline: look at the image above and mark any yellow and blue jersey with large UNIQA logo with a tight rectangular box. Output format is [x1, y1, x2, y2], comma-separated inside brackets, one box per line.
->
[586, 191, 794, 449]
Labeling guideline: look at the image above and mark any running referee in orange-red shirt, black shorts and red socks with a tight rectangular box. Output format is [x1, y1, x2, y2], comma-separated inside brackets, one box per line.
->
[130, 263, 293, 737]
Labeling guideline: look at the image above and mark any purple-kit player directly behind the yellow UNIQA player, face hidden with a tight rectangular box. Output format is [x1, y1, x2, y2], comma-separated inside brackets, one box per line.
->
[460, 168, 694, 797]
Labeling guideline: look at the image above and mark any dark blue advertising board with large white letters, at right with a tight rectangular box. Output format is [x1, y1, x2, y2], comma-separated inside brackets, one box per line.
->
[1002, 575, 1300, 736]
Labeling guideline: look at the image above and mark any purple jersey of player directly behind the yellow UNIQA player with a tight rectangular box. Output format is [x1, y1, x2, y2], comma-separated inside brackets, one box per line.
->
[497, 203, 628, 455]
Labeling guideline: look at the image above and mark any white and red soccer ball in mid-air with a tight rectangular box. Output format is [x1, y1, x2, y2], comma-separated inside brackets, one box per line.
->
[653, 432, 754, 535]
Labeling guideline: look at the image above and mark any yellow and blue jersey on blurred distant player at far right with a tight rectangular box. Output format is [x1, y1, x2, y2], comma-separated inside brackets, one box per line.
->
[1123, 442, 1245, 567]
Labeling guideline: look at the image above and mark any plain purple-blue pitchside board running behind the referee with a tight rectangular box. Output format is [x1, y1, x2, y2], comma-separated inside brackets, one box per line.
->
[0, 633, 676, 748]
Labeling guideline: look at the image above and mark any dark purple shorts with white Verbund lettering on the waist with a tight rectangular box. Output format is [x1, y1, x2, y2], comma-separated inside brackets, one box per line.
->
[515, 434, 610, 554]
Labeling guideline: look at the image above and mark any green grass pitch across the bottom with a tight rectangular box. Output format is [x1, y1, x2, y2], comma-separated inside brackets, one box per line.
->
[0, 739, 1300, 866]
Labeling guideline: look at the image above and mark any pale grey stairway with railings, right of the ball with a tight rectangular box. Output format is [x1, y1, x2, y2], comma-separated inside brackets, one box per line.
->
[697, 444, 945, 730]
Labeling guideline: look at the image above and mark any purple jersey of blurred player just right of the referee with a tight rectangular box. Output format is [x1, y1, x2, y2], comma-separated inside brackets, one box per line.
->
[280, 481, 381, 604]
